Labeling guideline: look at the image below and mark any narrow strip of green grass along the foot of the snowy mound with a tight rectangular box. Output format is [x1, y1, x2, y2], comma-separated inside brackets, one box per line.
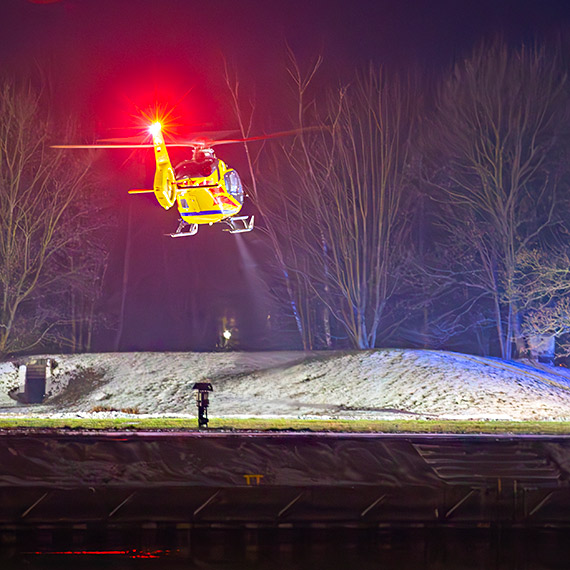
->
[0, 417, 570, 435]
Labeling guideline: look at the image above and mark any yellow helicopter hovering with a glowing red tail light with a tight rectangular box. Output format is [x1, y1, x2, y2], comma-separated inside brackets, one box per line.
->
[53, 121, 258, 238]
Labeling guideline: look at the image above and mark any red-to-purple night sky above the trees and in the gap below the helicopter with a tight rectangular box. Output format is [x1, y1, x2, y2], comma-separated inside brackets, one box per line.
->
[0, 0, 570, 350]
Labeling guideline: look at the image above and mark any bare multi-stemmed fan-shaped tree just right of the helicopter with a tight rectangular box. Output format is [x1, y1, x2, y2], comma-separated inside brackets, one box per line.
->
[258, 60, 415, 348]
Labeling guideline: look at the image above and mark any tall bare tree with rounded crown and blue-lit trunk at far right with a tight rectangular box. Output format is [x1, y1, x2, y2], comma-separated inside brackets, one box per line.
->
[427, 41, 567, 359]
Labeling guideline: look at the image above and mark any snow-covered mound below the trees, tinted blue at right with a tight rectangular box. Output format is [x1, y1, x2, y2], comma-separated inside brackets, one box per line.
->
[0, 349, 570, 420]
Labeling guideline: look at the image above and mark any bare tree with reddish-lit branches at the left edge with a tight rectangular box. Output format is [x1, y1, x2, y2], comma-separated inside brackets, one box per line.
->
[0, 80, 110, 355]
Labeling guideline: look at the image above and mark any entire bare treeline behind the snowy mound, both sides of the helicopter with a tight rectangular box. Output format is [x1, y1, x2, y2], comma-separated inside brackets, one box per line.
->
[0, 36, 570, 359]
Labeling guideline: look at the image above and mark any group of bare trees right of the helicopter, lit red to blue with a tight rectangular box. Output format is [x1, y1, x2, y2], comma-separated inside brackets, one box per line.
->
[228, 40, 570, 359]
